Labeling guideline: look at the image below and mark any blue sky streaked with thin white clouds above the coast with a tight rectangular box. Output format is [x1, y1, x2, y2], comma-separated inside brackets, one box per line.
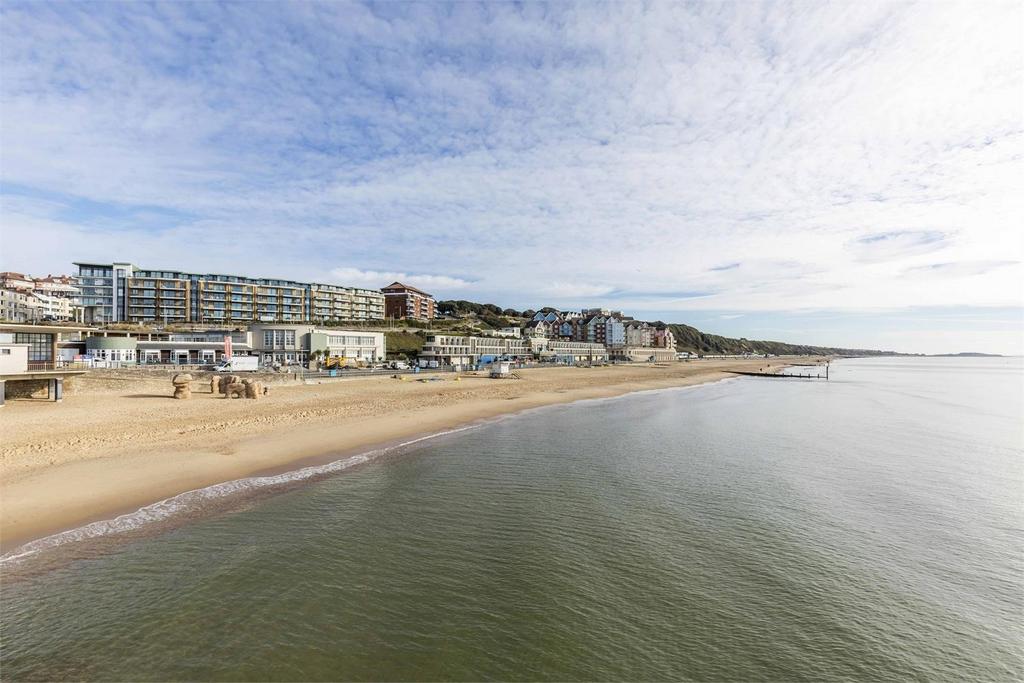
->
[0, 0, 1024, 353]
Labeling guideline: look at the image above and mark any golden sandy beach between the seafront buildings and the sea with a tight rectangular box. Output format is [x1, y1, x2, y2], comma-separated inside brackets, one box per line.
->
[0, 359, 799, 552]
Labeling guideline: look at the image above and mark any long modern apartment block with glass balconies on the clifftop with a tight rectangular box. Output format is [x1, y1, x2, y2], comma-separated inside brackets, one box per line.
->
[75, 263, 384, 324]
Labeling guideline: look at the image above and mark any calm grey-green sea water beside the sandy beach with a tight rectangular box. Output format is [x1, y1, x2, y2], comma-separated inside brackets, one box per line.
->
[0, 358, 1024, 681]
